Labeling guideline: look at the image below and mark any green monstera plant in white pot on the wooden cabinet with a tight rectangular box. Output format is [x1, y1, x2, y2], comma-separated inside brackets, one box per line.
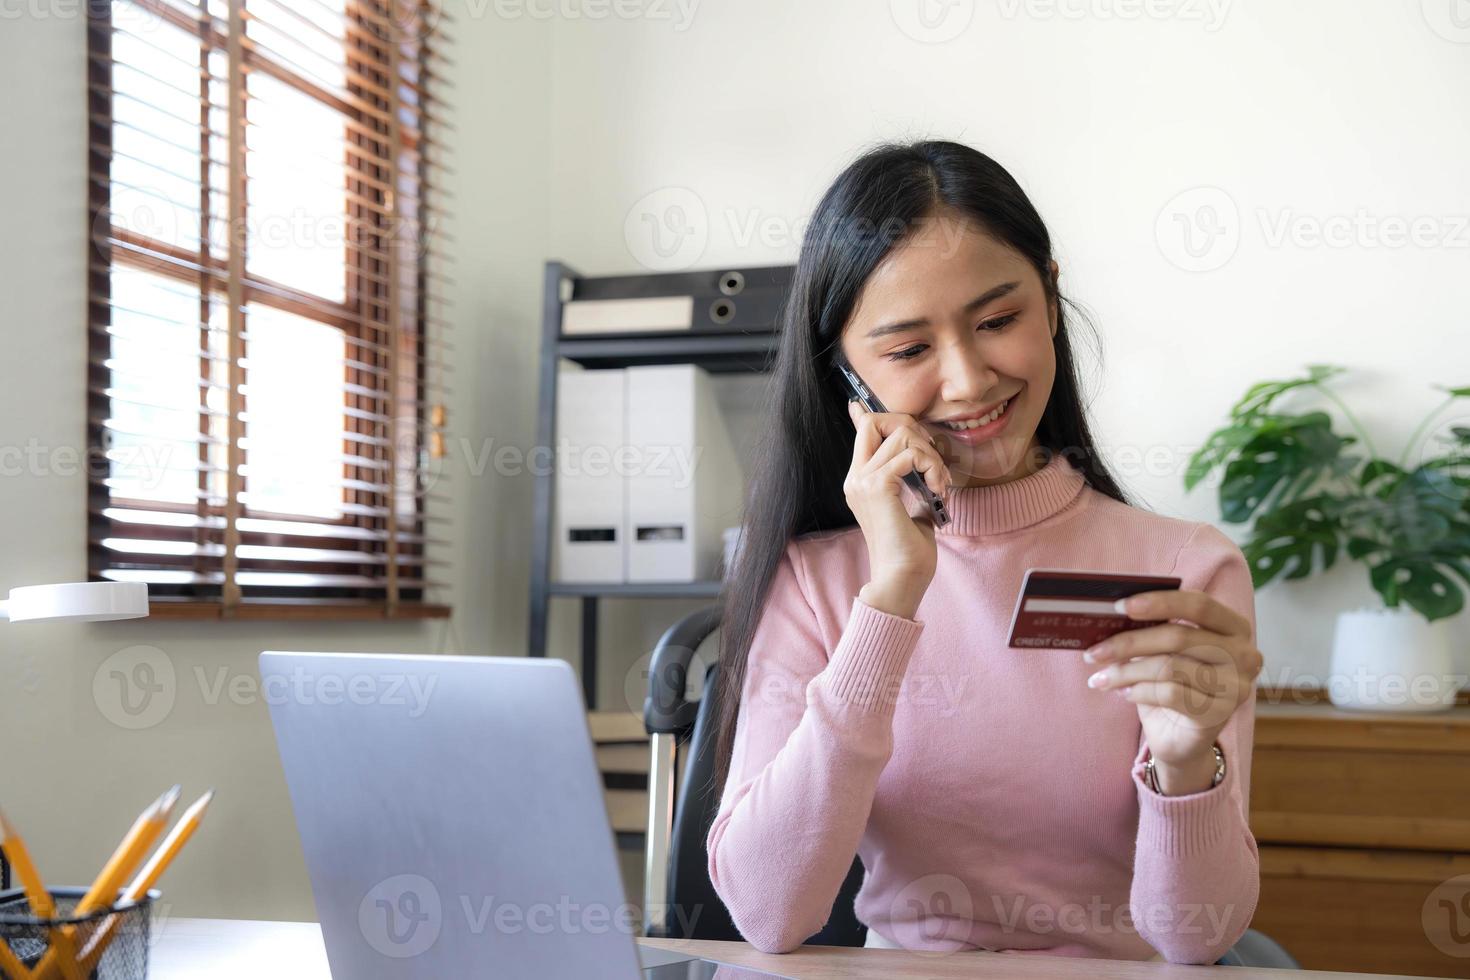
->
[1185, 364, 1470, 711]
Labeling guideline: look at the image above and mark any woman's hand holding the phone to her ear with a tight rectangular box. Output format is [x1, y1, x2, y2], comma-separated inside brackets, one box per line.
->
[842, 401, 950, 619]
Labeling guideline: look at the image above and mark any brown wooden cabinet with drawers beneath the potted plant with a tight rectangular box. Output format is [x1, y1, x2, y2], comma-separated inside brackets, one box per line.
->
[1251, 698, 1470, 977]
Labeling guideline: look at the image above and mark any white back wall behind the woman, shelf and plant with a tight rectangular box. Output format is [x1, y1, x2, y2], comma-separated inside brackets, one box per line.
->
[529, 0, 1470, 705]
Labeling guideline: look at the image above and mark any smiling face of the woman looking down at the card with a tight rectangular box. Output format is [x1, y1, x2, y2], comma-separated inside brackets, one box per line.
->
[839, 212, 1057, 486]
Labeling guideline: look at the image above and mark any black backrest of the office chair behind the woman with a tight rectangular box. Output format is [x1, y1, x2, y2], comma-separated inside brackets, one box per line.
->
[652, 652, 867, 946]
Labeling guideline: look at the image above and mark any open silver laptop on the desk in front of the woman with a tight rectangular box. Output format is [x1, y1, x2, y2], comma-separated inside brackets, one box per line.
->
[260, 651, 793, 980]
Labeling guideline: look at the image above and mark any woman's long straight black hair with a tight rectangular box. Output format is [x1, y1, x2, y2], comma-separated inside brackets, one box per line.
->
[711, 140, 1127, 792]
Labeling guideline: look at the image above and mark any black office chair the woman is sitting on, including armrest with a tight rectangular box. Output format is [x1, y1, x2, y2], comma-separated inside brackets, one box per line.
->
[644, 605, 1301, 970]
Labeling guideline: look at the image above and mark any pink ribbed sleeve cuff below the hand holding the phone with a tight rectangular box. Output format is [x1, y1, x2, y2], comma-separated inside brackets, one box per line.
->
[820, 597, 923, 714]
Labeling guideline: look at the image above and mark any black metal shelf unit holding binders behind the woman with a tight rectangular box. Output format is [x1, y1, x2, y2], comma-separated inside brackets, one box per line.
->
[531, 262, 792, 710]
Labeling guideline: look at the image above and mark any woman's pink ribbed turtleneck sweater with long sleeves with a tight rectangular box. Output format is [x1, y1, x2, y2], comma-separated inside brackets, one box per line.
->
[707, 455, 1260, 964]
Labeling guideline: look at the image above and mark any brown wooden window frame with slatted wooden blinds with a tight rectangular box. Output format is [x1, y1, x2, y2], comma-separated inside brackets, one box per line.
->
[87, 0, 453, 620]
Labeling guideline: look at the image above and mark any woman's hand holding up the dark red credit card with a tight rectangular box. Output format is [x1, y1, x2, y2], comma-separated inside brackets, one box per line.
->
[1083, 589, 1264, 767]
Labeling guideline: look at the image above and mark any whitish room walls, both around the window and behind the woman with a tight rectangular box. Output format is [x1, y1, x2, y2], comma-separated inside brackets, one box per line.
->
[0, 0, 1470, 918]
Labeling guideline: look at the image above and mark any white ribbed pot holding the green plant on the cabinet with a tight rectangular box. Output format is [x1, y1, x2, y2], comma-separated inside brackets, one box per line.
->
[1327, 605, 1464, 713]
